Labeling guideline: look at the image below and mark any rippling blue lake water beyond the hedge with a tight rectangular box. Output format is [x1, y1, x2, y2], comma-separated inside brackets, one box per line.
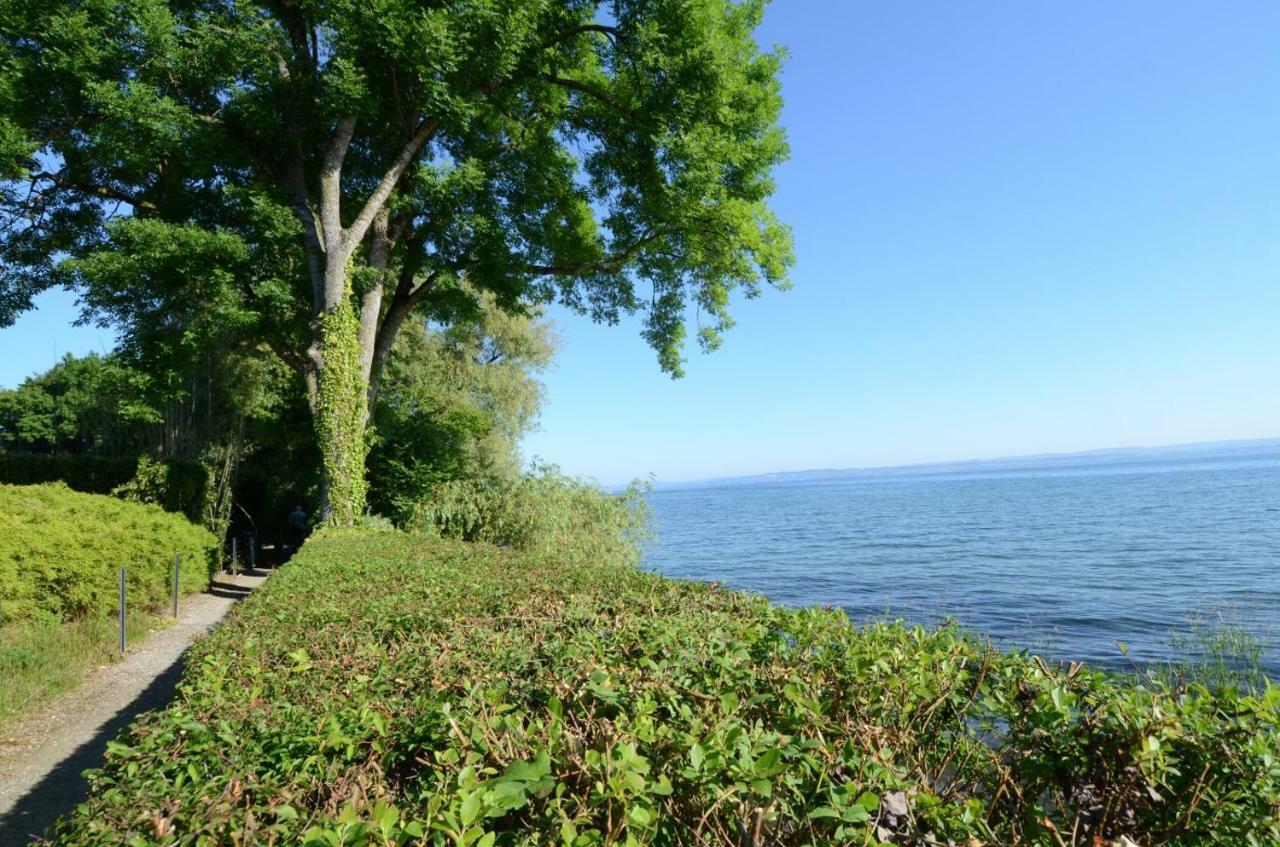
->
[645, 449, 1280, 678]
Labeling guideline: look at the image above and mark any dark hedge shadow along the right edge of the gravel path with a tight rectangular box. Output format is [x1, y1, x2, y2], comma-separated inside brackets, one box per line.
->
[0, 651, 187, 847]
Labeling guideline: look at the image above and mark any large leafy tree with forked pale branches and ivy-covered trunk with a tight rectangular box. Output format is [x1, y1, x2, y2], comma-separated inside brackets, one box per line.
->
[0, 0, 790, 522]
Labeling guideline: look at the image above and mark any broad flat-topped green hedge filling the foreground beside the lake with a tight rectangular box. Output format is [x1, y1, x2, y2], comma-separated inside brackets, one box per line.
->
[45, 530, 1280, 847]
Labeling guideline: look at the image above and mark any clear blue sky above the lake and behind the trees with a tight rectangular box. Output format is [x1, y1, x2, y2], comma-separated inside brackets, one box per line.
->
[0, 0, 1280, 485]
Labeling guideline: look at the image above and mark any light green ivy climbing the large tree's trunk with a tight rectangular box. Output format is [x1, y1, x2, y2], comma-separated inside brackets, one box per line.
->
[315, 298, 369, 526]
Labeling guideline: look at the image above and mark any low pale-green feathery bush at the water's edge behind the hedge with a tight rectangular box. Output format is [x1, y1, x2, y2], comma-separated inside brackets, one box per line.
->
[408, 466, 649, 564]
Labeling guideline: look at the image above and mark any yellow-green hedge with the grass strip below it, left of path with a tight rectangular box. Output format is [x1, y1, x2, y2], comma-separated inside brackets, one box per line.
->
[0, 484, 215, 722]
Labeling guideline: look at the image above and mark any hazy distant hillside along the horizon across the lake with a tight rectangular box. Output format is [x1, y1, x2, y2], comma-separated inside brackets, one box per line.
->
[654, 438, 1280, 490]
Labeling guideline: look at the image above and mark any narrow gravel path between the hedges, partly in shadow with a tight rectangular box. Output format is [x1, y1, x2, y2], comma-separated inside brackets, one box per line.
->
[0, 572, 266, 847]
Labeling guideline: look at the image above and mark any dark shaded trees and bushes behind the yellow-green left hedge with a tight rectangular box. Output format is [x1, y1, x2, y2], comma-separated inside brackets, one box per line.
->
[0, 347, 293, 535]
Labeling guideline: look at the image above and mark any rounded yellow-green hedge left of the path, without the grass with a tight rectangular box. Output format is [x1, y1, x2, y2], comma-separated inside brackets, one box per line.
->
[0, 484, 216, 622]
